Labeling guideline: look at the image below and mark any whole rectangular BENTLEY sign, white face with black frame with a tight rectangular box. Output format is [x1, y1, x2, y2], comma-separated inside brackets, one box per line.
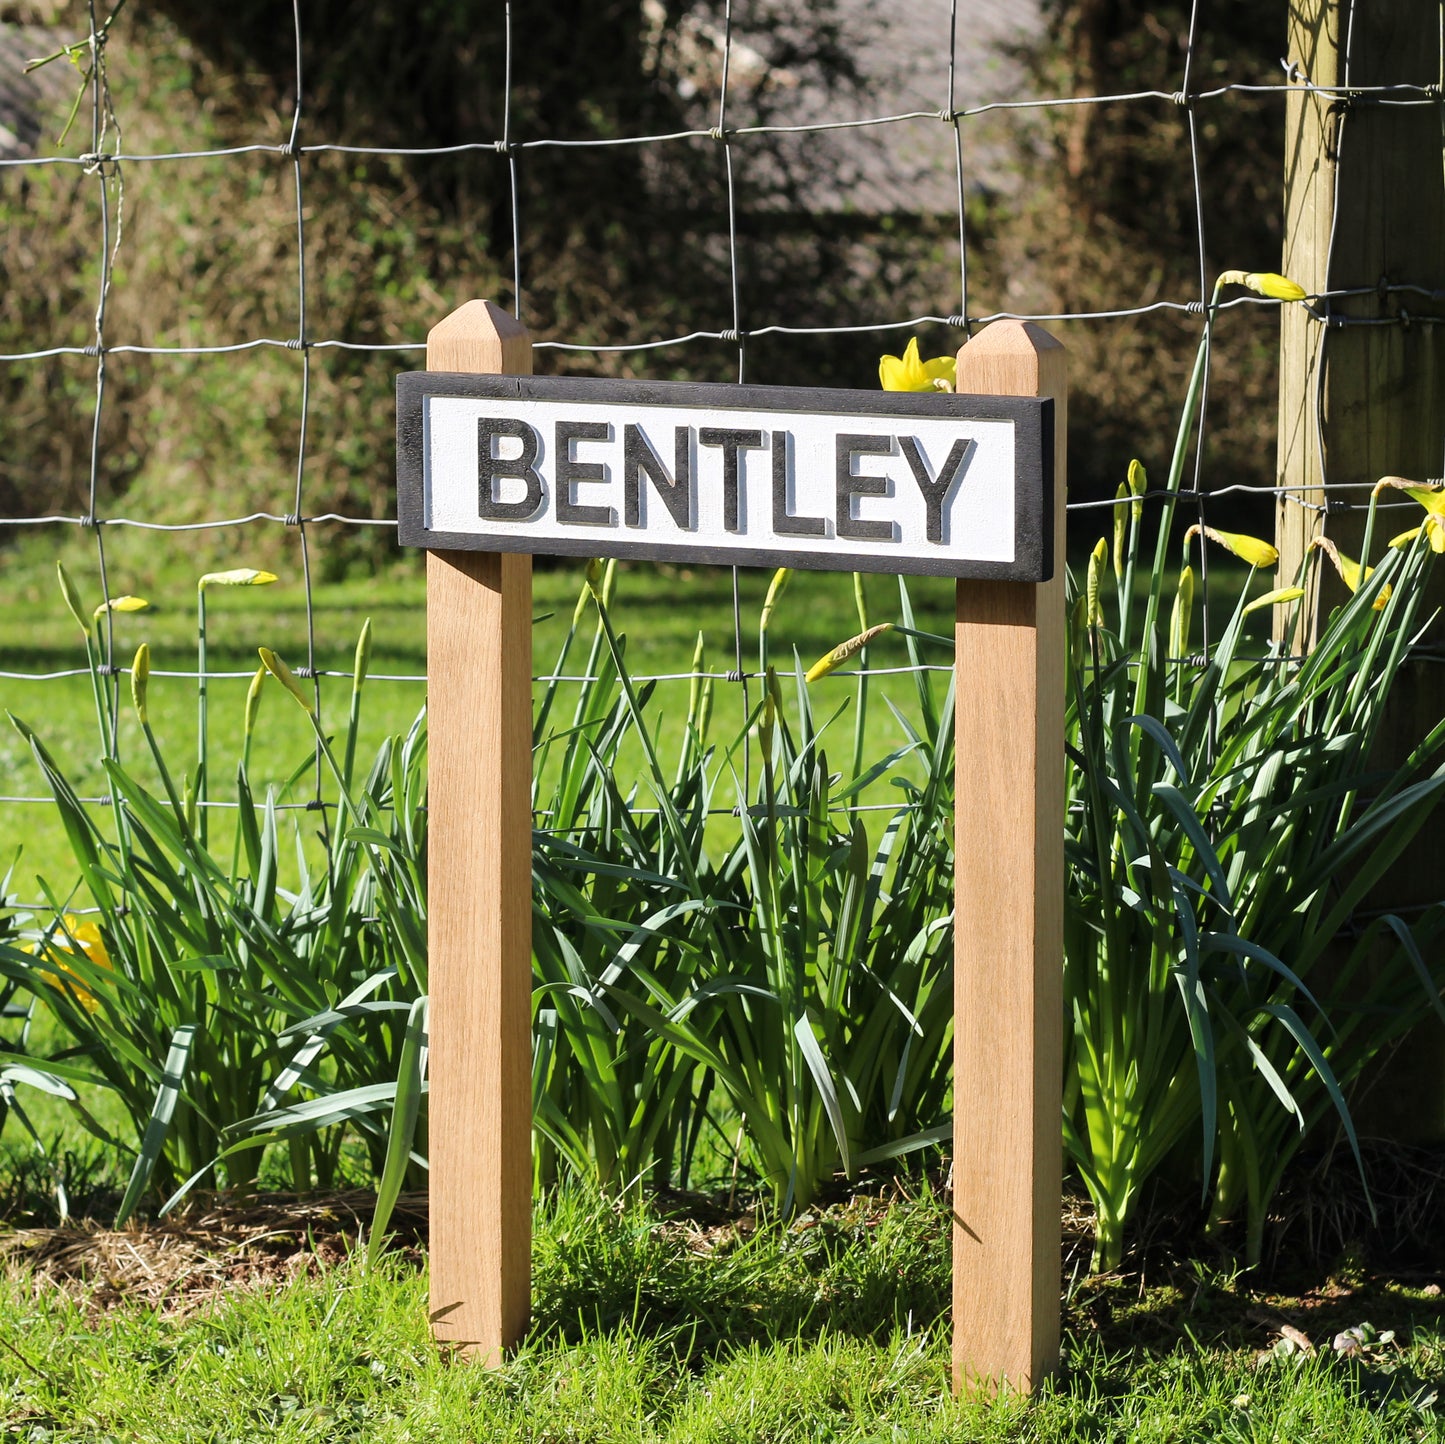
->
[397, 371, 1052, 580]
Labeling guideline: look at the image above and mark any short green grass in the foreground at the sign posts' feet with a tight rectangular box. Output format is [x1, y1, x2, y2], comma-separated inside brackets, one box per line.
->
[0, 1188, 1445, 1444]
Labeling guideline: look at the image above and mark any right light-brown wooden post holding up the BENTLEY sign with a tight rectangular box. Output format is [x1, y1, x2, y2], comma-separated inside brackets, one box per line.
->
[954, 321, 1068, 1391]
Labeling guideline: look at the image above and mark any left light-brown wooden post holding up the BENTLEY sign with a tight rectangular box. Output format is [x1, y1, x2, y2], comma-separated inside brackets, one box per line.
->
[426, 301, 532, 1366]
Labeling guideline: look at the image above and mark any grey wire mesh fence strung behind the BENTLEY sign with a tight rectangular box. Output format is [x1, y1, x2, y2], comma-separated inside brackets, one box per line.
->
[0, 0, 1445, 913]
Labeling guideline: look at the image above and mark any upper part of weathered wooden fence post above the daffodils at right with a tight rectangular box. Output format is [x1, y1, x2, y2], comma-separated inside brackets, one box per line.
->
[1276, 0, 1445, 638]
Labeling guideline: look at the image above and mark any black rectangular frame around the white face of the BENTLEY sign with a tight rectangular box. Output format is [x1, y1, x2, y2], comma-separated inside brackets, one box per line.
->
[396, 371, 1056, 583]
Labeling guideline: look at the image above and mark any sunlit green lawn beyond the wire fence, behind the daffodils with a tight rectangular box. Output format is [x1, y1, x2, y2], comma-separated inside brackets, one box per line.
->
[0, 528, 1243, 901]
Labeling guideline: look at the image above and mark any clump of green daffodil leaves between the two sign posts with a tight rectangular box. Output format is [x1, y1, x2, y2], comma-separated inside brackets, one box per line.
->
[533, 563, 952, 1208]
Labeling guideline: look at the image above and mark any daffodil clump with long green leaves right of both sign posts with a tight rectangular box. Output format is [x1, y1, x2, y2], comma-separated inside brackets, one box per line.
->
[1065, 381, 1445, 1268]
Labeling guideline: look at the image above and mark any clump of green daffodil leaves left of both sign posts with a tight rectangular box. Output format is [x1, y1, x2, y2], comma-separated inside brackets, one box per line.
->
[0, 571, 425, 1219]
